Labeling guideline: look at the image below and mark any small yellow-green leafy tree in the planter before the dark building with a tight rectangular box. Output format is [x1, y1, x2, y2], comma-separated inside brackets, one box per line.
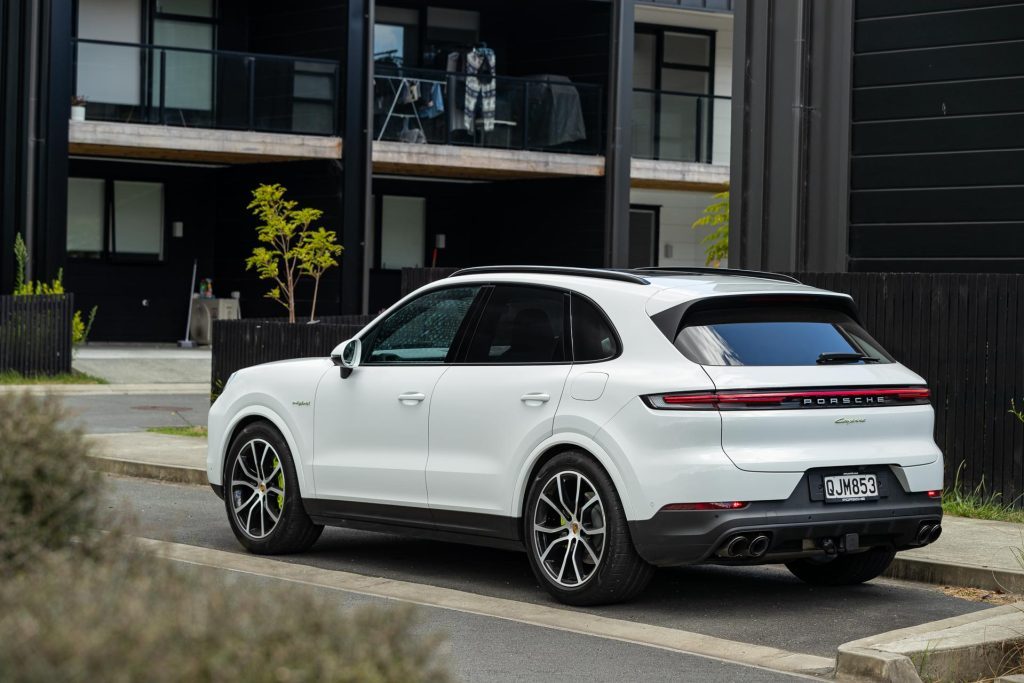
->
[246, 183, 342, 323]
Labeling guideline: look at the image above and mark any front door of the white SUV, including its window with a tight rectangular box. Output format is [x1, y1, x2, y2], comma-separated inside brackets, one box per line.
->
[313, 286, 480, 522]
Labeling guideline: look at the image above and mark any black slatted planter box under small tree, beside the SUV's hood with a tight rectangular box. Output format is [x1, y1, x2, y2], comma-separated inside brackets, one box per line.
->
[210, 315, 374, 395]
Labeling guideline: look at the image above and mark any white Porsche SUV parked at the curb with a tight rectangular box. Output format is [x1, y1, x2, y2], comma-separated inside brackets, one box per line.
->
[208, 266, 943, 604]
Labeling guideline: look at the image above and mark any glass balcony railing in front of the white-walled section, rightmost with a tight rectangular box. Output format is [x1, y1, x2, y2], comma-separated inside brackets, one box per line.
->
[633, 89, 732, 166]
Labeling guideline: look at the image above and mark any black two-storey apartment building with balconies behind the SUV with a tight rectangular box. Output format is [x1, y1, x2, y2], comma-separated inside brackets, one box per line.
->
[0, 0, 732, 340]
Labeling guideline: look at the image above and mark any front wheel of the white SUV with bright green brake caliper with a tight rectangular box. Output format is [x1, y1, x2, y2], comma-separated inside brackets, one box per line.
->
[224, 422, 324, 555]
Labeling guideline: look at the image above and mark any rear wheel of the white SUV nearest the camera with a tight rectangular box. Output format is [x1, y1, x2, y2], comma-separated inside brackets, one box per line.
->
[523, 451, 654, 605]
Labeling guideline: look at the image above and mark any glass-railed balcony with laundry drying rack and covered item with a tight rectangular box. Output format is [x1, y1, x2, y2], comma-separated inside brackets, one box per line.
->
[374, 63, 605, 155]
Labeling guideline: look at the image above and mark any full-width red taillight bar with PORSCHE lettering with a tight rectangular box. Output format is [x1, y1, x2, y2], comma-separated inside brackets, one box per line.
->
[644, 386, 931, 411]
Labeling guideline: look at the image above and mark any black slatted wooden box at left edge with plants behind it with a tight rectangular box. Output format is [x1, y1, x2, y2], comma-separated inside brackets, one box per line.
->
[0, 294, 75, 377]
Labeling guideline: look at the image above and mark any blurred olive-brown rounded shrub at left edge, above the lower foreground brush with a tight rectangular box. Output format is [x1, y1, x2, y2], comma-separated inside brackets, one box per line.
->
[0, 394, 112, 570]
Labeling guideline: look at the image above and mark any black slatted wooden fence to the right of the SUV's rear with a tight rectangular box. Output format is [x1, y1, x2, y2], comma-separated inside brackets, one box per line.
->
[793, 272, 1024, 505]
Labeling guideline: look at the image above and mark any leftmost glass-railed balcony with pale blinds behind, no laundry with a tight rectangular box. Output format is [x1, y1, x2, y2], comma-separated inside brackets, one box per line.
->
[73, 40, 339, 136]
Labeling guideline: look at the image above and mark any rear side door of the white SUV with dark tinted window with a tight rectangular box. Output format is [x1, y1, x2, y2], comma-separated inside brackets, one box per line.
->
[427, 285, 571, 535]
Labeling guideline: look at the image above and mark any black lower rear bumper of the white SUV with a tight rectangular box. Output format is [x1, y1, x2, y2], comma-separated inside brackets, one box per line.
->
[630, 468, 942, 566]
